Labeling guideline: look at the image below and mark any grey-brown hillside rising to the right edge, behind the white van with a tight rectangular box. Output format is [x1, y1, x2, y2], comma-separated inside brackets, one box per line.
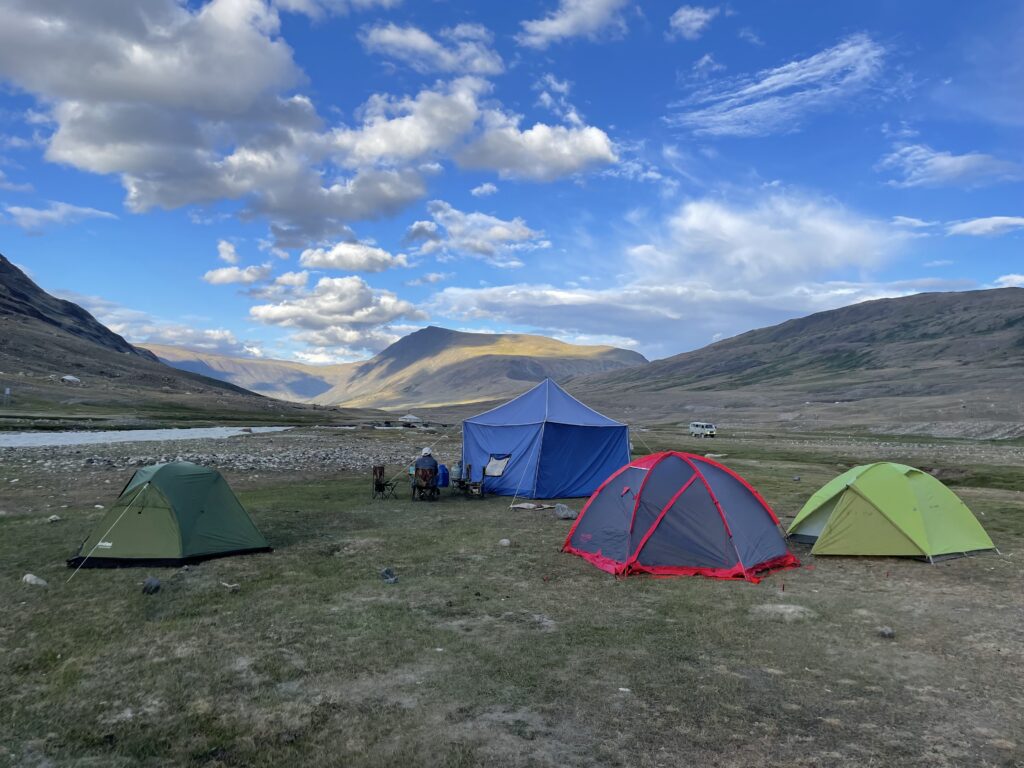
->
[572, 288, 1024, 436]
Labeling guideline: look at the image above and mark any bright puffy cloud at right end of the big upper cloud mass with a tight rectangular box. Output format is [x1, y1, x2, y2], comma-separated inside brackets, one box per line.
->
[457, 112, 617, 181]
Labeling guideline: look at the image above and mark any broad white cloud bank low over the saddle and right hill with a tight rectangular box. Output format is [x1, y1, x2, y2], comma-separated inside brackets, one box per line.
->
[429, 195, 913, 354]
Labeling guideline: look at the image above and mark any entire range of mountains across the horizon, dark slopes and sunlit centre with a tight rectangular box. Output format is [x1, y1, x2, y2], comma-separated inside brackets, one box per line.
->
[0, 249, 1024, 437]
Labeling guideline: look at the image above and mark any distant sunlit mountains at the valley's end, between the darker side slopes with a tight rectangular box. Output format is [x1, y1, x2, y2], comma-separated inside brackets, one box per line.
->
[148, 327, 647, 409]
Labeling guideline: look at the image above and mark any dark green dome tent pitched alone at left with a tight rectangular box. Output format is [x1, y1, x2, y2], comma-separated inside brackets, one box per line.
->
[68, 462, 270, 568]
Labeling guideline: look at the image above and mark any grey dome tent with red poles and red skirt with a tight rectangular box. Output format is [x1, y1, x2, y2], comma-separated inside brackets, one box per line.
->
[562, 451, 800, 583]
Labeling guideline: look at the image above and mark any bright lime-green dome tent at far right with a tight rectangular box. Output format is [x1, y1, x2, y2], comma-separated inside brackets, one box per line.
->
[788, 462, 994, 560]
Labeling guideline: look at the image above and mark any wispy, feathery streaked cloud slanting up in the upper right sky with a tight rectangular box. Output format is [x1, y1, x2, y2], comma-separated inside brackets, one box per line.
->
[668, 34, 886, 136]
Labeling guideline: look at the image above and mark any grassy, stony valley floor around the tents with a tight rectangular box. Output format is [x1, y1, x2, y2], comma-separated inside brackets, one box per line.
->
[0, 428, 1024, 767]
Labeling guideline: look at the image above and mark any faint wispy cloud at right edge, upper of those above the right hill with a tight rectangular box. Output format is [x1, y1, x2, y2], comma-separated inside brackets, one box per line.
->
[878, 144, 1024, 187]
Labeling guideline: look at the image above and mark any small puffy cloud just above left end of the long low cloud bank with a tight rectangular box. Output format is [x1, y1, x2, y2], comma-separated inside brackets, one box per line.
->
[406, 200, 551, 268]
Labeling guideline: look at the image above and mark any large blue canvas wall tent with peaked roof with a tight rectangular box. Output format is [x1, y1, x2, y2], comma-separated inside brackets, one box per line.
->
[462, 379, 630, 499]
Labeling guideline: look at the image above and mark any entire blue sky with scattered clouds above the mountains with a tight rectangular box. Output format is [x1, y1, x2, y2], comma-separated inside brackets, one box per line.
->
[0, 0, 1024, 364]
